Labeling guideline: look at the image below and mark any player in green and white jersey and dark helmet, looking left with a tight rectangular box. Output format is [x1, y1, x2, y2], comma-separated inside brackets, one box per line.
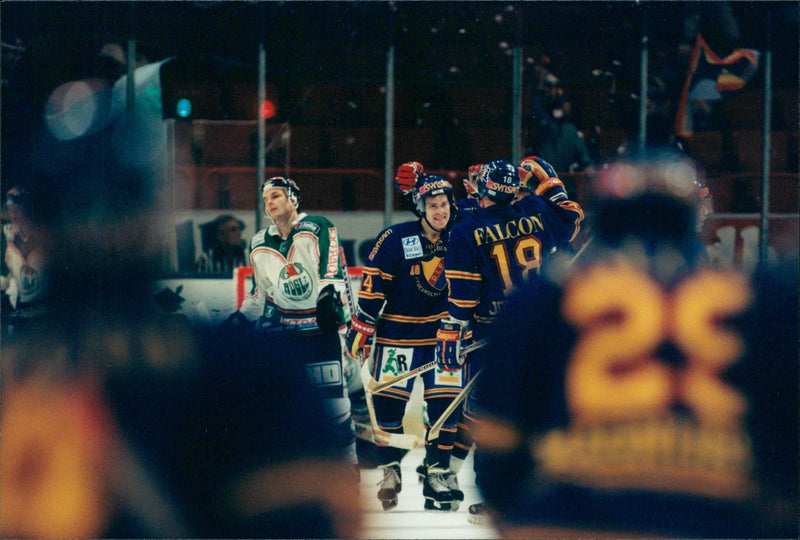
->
[227, 176, 357, 464]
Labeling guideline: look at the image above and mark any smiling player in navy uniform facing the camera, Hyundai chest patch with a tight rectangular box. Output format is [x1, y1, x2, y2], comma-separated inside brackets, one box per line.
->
[346, 172, 463, 510]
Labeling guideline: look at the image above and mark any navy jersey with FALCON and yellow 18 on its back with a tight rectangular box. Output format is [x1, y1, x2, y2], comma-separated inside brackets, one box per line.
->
[445, 192, 583, 332]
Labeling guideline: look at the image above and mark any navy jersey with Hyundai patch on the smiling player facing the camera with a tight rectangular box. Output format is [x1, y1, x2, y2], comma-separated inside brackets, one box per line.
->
[358, 221, 447, 347]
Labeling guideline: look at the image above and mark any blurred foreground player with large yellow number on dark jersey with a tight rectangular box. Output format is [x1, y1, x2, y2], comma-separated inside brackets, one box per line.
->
[473, 154, 798, 538]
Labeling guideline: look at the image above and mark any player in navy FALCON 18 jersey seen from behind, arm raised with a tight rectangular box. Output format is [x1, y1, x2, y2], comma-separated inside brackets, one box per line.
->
[436, 160, 583, 513]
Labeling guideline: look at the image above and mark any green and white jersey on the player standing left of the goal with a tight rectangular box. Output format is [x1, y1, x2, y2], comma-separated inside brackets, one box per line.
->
[240, 213, 345, 331]
